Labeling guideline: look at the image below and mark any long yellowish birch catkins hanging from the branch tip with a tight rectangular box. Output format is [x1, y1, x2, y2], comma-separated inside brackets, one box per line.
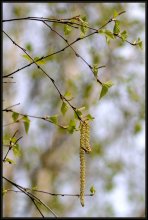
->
[80, 121, 91, 206]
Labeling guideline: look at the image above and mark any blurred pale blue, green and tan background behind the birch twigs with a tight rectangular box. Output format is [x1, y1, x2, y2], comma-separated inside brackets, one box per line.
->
[3, 2, 145, 217]
